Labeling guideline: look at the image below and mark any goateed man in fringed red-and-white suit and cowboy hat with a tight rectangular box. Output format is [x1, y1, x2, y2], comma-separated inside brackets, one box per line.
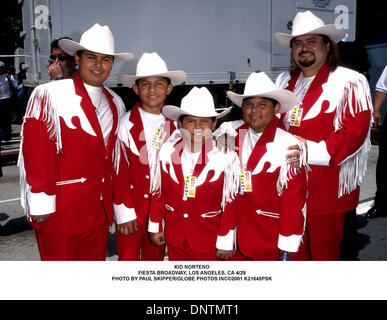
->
[274, 11, 372, 260]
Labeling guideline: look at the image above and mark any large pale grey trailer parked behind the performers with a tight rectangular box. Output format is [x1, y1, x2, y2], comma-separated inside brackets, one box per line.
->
[22, 0, 356, 87]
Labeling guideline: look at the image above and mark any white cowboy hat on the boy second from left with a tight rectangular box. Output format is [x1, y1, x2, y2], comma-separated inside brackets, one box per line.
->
[120, 52, 187, 88]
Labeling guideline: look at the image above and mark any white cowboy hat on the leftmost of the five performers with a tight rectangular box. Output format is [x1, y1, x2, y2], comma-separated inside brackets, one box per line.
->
[58, 23, 134, 61]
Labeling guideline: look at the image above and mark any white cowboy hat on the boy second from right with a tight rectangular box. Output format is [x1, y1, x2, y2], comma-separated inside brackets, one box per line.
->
[227, 72, 297, 113]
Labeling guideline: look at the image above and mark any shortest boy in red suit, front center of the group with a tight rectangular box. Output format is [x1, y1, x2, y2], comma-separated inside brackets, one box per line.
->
[148, 87, 239, 261]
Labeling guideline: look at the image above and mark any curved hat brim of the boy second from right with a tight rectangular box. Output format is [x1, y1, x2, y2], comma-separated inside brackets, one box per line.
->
[227, 89, 297, 113]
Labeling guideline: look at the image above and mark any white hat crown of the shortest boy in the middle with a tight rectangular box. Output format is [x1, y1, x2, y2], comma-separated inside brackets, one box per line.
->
[181, 87, 215, 117]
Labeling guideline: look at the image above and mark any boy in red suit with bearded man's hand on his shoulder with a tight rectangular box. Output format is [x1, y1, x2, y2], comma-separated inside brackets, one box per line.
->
[219, 72, 308, 261]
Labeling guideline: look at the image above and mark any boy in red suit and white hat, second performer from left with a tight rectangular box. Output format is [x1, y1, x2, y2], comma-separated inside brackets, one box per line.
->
[114, 52, 186, 260]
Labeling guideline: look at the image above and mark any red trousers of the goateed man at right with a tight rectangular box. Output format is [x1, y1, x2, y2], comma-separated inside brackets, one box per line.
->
[306, 212, 345, 261]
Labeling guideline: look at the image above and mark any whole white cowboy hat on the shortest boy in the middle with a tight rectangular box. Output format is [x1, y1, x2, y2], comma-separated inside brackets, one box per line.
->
[162, 87, 232, 120]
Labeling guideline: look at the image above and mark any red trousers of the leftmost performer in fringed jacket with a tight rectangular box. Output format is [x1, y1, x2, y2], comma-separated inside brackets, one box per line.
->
[35, 218, 109, 261]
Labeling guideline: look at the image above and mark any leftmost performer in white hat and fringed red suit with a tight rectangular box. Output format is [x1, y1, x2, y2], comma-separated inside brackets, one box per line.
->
[19, 24, 133, 260]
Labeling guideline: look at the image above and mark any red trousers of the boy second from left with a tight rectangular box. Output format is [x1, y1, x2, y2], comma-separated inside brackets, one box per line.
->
[116, 223, 165, 261]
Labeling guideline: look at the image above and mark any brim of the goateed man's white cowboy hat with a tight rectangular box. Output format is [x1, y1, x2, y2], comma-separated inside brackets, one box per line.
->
[273, 24, 346, 48]
